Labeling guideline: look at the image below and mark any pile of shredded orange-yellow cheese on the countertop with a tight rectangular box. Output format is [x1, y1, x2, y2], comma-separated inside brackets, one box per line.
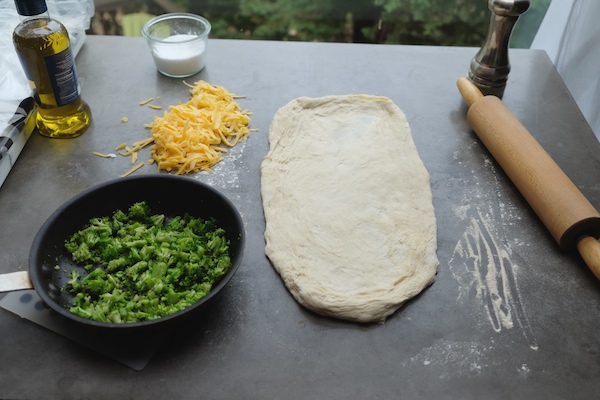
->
[147, 81, 250, 175]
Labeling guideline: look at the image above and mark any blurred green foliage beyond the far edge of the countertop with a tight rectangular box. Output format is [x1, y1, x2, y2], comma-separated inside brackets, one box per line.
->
[119, 0, 551, 48]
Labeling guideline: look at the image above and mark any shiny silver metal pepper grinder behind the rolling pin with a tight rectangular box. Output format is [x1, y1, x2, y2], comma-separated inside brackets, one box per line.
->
[469, 0, 531, 98]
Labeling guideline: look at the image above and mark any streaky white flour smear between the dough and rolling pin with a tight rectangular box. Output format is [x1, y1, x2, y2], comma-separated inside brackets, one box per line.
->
[449, 156, 538, 350]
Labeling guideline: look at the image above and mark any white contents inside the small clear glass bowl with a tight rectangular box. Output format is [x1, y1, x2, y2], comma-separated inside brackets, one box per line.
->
[153, 35, 206, 77]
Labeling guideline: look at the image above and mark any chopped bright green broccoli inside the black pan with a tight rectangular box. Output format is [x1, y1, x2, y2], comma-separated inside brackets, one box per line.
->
[65, 202, 231, 323]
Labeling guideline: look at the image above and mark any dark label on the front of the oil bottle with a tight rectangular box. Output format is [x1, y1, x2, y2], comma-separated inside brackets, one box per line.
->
[44, 47, 79, 106]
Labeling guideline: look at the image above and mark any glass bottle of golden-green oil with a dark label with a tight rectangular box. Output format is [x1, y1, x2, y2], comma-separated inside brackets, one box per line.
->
[13, 0, 92, 138]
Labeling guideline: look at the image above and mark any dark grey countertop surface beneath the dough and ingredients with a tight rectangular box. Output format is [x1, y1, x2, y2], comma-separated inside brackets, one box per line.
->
[0, 36, 600, 400]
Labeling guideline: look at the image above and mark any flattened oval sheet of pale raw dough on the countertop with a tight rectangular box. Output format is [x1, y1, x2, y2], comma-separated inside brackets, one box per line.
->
[261, 95, 439, 323]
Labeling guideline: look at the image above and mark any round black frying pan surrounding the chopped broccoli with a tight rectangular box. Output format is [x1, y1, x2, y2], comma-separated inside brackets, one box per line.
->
[0, 174, 245, 332]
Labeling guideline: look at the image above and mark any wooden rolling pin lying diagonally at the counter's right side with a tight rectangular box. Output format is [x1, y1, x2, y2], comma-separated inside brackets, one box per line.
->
[457, 78, 600, 279]
